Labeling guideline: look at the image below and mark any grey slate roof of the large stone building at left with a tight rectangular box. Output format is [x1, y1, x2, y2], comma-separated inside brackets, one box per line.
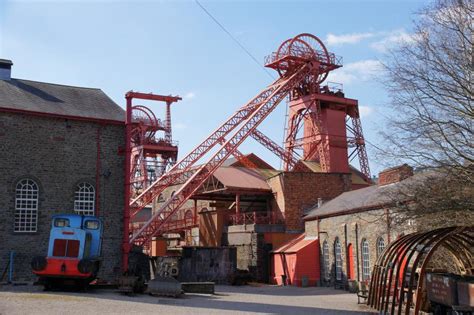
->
[0, 79, 125, 122]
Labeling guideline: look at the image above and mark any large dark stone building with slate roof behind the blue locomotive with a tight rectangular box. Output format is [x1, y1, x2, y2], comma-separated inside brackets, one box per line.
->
[0, 60, 125, 281]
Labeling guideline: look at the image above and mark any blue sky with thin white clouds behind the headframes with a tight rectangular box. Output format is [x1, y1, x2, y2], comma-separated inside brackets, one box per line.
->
[0, 0, 427, 174]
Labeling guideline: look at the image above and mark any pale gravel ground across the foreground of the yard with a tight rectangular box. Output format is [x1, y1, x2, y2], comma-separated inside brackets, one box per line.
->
[0, 285, 378, 315]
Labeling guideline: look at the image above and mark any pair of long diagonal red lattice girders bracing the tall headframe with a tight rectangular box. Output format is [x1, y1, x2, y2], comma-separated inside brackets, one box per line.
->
[130, 63, 313, 245]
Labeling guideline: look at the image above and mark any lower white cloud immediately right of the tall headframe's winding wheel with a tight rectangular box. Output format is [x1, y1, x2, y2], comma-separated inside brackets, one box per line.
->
[328, 59, 382, 85]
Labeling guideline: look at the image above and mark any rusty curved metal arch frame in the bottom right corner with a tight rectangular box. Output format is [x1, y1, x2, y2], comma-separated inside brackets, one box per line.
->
[367, 226, 474, 315]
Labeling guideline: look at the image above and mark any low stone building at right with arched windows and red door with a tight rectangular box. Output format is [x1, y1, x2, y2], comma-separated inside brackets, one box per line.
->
[304, 164, 474, 288]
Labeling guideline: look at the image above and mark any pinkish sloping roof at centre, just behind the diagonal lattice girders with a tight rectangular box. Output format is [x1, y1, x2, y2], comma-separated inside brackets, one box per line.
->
[213, 166, 271, 191]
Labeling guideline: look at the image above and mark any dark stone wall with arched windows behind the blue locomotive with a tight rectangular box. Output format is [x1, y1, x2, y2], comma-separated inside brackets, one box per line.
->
[0, 113, 124, 280]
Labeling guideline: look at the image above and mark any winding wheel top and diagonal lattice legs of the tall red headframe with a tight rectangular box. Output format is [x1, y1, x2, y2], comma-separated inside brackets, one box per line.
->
[123, 35, 374, 266]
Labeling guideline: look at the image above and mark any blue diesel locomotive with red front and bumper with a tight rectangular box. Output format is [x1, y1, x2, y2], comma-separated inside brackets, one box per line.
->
[31, 214, 103, 289]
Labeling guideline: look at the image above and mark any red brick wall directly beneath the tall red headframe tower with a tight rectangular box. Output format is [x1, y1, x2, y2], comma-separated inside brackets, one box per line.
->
[268, 172, 351, 231]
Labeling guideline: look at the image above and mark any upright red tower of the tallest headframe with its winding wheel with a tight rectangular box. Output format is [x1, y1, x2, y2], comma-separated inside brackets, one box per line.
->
[266, 34, 370, 182]
